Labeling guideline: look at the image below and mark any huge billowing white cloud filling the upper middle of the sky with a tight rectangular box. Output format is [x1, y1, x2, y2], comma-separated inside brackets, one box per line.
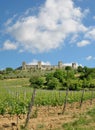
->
[7, 0, 87, 53]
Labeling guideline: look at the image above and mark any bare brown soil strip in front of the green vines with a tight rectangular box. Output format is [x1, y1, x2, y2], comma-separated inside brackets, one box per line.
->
[0, 99, 95, 130]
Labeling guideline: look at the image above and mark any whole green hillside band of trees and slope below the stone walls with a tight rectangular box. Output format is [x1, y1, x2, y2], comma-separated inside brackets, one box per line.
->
[0, 66, 95, 90]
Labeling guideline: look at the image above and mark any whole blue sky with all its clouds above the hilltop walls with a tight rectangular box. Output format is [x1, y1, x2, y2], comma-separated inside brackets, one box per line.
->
[0, 0, 95, 69]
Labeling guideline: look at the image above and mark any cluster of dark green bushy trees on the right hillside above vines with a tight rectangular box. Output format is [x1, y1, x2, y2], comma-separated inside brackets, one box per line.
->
[29, 66, 95, 90]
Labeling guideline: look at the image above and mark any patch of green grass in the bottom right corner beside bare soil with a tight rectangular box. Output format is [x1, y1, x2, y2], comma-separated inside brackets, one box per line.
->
[62, 108, 95, 130]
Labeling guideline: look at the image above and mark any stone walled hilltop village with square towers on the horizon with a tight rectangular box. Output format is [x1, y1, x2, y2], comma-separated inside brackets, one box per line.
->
[21, 61, 77, 70]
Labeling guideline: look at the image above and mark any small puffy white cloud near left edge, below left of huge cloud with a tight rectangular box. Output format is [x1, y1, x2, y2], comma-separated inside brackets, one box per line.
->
[2, 40, 17, 50]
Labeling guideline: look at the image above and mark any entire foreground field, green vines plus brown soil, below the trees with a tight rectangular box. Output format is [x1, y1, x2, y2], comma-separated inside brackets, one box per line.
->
[0, 79, 95, 130]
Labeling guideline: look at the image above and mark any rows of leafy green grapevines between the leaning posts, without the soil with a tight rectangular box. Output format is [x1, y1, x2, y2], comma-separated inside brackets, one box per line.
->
[0, 83, 95, 115]
